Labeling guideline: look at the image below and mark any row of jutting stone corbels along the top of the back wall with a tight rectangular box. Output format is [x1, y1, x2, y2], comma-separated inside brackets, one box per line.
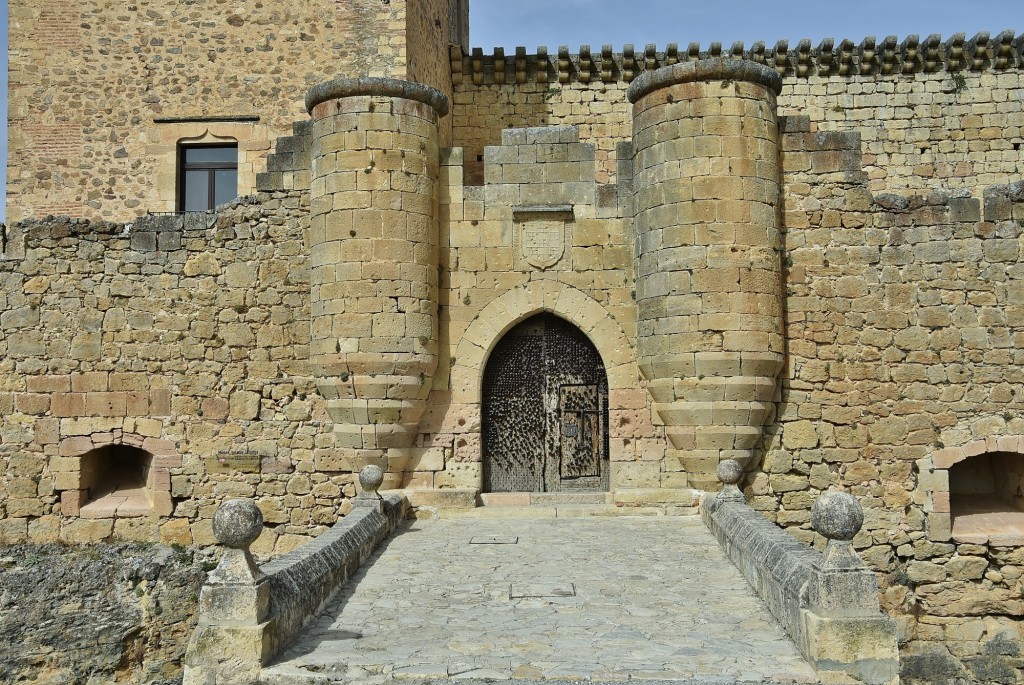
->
[451, 30, 1024, 86]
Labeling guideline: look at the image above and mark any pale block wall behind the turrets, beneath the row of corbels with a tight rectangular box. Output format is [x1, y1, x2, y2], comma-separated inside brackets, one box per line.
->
[453, 41, 1024, 197]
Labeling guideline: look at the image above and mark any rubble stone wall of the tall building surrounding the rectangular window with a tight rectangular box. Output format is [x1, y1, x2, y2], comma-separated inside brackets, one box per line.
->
[7, 0, 464, 221]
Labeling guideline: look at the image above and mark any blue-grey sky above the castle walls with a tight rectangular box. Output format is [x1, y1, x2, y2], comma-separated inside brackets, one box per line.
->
[0, 0, 1024, 220]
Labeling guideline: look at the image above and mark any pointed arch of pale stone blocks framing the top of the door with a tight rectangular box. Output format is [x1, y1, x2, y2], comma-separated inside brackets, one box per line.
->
[451, 281, 638, 404]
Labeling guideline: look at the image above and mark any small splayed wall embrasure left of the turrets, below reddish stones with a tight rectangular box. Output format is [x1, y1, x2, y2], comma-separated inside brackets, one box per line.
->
[80, 444, 153, 518]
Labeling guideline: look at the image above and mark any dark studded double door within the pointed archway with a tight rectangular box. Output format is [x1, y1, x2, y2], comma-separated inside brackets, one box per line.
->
[482, 313, 608, 493]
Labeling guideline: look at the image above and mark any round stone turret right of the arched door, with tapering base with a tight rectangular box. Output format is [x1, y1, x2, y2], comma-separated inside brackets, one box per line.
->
[629, 58, 784, 488]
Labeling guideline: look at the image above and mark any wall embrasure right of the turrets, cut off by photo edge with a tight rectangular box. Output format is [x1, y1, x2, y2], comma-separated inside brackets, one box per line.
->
[949, 452, 1024, 540]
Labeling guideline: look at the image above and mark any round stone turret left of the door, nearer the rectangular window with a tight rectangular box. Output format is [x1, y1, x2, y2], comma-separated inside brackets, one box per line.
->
[306, 78, 449, 470]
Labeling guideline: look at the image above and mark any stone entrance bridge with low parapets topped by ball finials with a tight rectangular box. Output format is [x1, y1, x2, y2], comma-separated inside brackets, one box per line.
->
[184, 462, 898, 685]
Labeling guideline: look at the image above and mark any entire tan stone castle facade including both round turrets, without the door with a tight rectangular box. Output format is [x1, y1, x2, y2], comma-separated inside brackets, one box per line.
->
[6, 0, 1024, 680]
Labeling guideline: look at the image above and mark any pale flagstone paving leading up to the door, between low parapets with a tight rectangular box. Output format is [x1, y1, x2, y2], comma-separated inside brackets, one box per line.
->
[264, 517, 817, 683]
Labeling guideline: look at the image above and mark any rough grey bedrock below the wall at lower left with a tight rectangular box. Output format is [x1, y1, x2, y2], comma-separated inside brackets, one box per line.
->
[0, 544, 206, 685]
